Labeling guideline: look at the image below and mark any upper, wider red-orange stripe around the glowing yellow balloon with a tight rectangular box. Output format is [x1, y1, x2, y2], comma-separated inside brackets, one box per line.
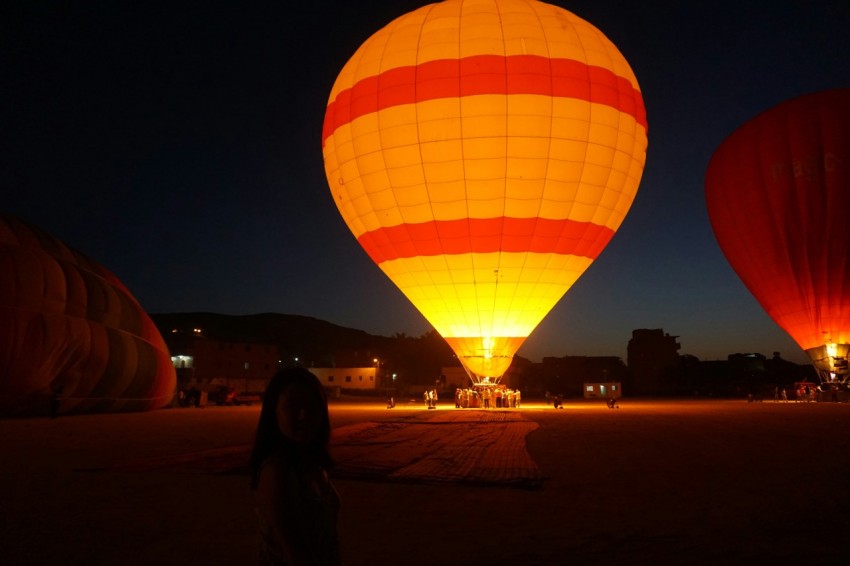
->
[322, 55, 647, 146]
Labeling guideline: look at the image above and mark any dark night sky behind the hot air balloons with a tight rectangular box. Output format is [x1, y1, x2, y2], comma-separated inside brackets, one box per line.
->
[0, 0, 850, 363]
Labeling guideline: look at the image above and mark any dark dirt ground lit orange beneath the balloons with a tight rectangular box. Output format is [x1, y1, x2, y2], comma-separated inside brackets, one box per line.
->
[0, 399, 850, 566]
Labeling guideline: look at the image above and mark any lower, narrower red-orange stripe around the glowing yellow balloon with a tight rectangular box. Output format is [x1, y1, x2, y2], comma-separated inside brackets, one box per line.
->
[358, 218, 614, 264]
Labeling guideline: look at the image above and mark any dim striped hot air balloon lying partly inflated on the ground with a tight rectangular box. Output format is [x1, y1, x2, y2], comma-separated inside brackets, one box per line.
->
[0, 216, 176, 416]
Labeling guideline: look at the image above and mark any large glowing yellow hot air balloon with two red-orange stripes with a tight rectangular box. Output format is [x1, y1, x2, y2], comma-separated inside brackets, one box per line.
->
[322, 0, 647, 383]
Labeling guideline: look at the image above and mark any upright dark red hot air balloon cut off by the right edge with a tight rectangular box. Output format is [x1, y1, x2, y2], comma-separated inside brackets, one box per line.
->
[705, 89, 850, 384]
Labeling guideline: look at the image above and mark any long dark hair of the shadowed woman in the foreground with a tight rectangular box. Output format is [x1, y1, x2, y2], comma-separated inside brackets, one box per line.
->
[250, 367, 333, 489]
